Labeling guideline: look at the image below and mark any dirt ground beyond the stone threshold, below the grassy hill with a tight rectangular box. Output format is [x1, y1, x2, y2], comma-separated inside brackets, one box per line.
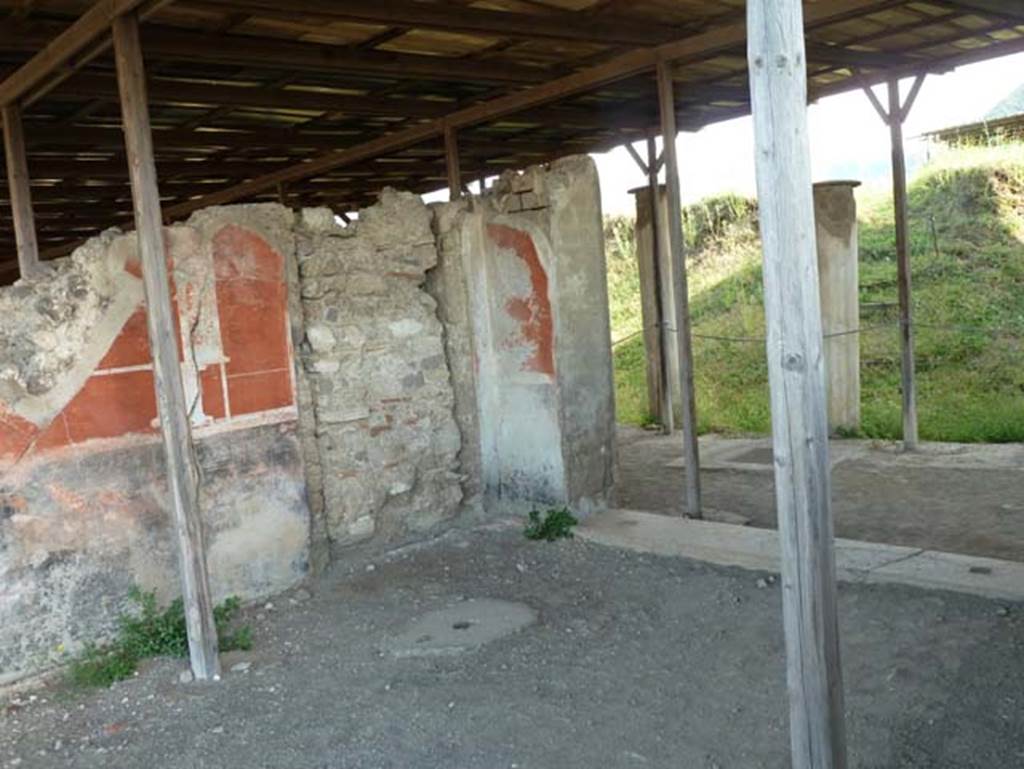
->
[616, 427, 1024, 560]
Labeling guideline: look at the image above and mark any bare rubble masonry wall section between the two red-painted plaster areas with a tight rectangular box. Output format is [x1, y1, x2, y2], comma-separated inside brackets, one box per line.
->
[298, 190, 462, 547]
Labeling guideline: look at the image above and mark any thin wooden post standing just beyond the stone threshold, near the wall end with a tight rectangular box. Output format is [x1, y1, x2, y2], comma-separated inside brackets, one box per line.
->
[657, 59, 702, 518]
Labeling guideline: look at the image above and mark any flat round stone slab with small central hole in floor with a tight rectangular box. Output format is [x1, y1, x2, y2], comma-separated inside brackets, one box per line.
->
[386, 598, 537, 656]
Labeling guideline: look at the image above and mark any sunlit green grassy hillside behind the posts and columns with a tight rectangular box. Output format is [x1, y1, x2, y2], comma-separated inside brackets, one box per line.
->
[606, 144, 1024, 442]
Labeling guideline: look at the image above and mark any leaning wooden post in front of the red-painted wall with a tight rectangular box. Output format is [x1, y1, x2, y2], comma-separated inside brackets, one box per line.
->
[113, 13, 220, 681]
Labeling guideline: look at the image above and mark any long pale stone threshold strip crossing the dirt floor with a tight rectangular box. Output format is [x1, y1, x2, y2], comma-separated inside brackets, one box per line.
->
[578, 510, 1024, 602]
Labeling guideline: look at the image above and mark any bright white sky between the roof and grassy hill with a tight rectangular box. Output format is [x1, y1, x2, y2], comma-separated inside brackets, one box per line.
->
[595, 53, 1024, 214]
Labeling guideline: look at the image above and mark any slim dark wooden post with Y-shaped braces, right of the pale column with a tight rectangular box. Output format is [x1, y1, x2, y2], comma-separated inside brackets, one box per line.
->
[888, 78, 920, 452]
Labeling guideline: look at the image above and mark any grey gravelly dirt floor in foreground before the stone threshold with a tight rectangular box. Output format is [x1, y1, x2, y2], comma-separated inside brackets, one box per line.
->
[0, 525, 1024, 769]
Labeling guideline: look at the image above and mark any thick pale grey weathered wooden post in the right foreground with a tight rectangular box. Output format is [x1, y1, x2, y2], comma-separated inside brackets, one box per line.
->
[746, 0, 846, 769]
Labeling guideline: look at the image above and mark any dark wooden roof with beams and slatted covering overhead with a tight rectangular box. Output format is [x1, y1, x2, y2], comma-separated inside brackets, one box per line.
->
[0, 0, 1024, 284]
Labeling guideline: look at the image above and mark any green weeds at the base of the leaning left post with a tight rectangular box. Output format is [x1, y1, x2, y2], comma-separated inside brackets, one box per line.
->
[69, 587, 253, 687]
